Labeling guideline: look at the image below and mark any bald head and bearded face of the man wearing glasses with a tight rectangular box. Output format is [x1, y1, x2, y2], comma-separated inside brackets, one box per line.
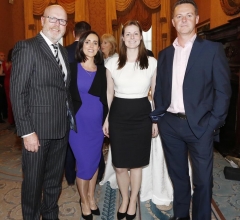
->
[41, 5, 67, 43]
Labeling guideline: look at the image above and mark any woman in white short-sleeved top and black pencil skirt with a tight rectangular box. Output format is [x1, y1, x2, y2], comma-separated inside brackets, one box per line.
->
[103, 21, 158, 220]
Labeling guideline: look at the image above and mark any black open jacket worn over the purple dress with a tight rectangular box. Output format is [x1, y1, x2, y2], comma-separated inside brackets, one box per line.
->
[69, 62, 108, 123]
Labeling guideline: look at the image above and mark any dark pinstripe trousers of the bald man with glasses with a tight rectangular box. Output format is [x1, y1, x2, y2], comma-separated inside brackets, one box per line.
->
[21, 134, 68, 220]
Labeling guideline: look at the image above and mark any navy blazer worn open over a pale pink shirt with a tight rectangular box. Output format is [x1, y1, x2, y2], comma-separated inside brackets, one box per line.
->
[150, 37, 231, 138]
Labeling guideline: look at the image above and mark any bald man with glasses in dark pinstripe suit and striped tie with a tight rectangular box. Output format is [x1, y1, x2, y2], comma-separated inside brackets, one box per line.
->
[11, 5, 76, 220]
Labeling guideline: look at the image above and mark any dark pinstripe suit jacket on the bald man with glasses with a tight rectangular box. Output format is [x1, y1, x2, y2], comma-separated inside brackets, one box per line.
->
[10, 34, 72, 139]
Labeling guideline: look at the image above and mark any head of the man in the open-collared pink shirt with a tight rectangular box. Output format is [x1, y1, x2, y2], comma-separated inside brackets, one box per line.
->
[172, 4, 199, 37]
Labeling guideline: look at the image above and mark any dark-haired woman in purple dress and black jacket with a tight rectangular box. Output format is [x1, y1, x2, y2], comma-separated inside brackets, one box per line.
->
[69, 31, 108, 220]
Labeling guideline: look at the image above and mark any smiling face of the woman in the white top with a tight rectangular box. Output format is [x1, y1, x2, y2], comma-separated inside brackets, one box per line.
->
[122, 25, 142, 49]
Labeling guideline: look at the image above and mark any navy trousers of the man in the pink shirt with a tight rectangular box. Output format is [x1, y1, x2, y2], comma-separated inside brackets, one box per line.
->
[158, 113, 213, 220]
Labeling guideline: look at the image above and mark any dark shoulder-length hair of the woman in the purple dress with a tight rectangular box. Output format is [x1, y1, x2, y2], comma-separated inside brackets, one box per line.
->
[75, 30, 103, 65]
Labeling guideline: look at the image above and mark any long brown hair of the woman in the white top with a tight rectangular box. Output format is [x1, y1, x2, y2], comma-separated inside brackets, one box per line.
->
[118, 20, 148, 70]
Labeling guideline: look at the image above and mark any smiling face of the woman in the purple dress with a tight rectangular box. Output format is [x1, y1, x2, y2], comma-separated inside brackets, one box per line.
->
[83, 34, 99, 57]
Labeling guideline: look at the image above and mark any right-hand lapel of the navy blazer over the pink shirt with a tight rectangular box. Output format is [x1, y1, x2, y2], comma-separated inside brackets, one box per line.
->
[185, 37, 203, 75]
